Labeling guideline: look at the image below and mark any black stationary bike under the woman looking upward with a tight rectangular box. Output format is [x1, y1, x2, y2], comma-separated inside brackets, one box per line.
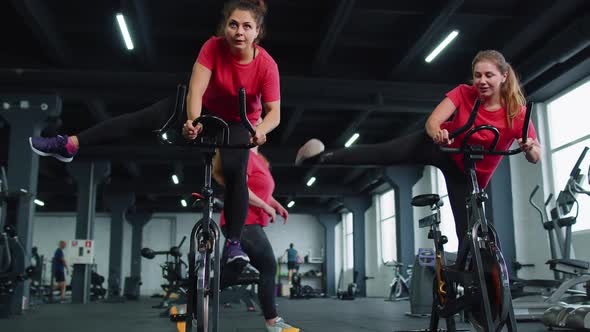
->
[158, 86, 256, 332]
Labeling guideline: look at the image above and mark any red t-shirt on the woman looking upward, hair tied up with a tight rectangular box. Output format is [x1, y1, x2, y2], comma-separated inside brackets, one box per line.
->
[197, 37, 281, 123]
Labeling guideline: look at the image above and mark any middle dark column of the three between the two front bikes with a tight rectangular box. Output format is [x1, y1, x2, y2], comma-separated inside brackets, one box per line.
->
[342, 196, 371, 296]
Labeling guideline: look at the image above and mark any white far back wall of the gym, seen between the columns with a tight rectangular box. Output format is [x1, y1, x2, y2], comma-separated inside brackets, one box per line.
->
[33, 213, 324, 295]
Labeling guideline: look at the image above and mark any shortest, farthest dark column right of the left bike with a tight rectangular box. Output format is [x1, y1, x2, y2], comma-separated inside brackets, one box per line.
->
[317, 213, 340, 296]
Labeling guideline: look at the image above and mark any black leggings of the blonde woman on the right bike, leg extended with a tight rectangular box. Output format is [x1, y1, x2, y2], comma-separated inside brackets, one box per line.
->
[319, 130, 469, 246]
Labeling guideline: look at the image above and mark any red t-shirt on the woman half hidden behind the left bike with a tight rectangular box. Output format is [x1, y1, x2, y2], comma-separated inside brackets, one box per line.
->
[220, 151, 275, 227]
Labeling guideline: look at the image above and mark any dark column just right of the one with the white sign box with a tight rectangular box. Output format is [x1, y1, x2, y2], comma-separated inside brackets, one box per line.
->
[104, 189, 135, 298]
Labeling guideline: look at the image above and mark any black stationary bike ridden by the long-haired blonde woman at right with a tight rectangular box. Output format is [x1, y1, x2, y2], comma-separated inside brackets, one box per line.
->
[412, 100, 532, 332]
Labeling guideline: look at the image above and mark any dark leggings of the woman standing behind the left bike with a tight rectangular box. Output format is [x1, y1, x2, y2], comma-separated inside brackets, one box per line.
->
[221, 224, 278, 319]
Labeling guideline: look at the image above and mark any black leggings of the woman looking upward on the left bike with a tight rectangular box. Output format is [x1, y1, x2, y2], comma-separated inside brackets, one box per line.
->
[76, 97, 250, 240]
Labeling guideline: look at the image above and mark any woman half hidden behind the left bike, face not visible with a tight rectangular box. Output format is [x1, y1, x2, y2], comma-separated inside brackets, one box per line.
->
[213, 147, 298, 331]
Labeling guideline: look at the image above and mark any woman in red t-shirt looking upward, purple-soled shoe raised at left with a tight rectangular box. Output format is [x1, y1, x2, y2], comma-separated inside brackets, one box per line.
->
[29, 0, 280, 263]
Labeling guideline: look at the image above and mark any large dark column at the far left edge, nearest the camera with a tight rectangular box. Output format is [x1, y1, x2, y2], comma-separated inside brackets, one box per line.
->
[0, 95, 61, 314]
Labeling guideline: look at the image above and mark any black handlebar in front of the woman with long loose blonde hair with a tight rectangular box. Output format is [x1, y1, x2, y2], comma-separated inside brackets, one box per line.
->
[440, 99, 533, 155]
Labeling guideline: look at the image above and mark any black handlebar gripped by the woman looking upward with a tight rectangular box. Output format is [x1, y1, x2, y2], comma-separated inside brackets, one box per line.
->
[193, 88, 256, 149]
